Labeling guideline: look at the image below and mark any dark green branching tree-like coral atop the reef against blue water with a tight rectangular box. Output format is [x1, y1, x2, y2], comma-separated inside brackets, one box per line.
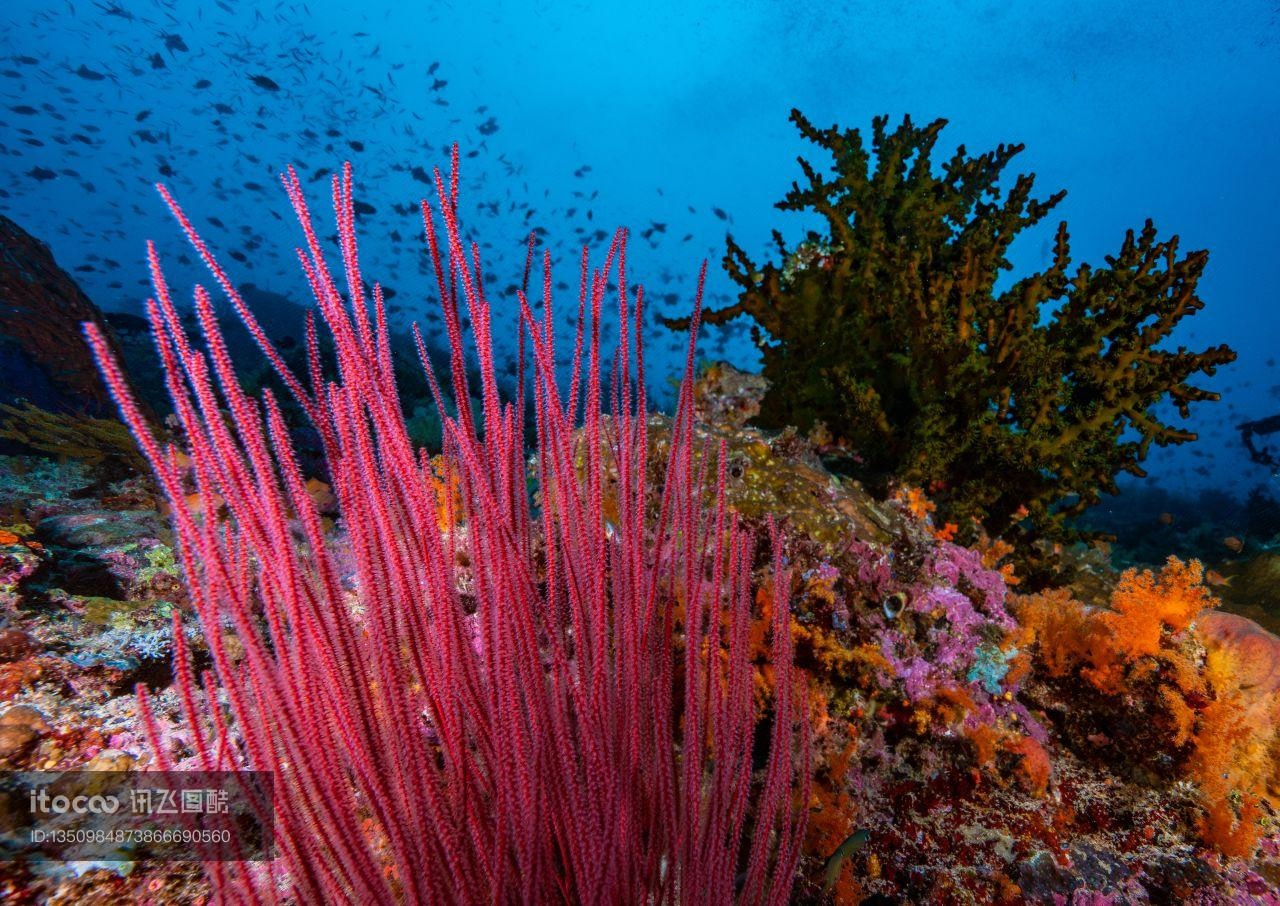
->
[667, 111, 1235, 563]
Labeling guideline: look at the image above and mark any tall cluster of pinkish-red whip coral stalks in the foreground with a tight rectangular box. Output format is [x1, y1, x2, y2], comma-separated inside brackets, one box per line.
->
[86, 148, 809, 903]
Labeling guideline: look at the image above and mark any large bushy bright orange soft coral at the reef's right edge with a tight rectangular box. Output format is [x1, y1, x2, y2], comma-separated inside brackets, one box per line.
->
[1015, 557, 1280, 856]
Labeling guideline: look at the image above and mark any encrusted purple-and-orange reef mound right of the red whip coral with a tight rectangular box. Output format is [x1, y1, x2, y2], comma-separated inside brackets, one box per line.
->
[686, 369, 1280, 903]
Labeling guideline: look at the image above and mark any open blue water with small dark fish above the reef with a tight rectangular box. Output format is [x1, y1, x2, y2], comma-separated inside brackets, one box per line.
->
[0, 0, 1280, 501]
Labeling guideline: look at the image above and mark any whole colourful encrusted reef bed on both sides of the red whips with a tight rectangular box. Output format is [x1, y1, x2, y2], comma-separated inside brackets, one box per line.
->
[0, 409, 1280, 903]
